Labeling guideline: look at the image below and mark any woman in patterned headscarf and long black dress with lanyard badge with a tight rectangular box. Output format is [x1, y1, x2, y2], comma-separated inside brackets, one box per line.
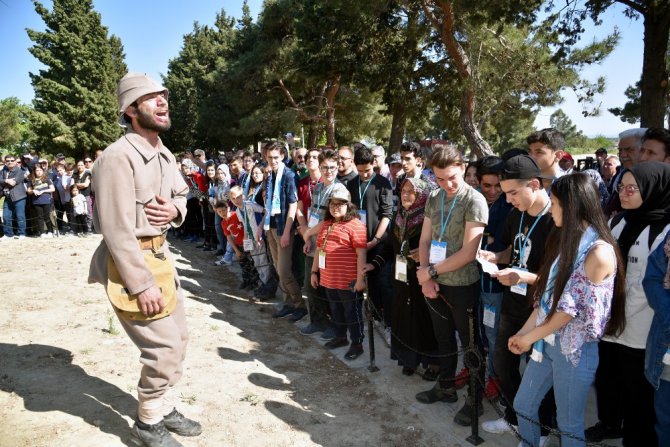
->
[364, 178, 439, 380]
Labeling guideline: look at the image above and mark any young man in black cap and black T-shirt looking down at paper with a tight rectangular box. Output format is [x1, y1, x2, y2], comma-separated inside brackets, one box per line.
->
[480, 155, 554, 443]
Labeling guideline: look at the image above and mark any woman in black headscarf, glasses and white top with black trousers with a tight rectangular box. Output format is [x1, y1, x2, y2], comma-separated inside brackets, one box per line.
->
[586, 162, 670, 446]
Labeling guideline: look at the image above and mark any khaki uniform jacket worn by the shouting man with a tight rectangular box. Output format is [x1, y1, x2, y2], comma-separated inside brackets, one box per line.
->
[88, 129, 188, 295]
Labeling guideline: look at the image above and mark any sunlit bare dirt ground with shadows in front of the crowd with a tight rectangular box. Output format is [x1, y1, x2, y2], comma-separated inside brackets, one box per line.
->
[0, 236, 608, 447]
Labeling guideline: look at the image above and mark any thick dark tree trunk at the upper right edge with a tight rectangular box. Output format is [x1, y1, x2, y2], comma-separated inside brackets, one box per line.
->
[640, 7, 670, 127]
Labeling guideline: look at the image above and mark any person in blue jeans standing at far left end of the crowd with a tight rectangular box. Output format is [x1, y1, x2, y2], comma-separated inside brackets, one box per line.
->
[0, 155, 28, 240]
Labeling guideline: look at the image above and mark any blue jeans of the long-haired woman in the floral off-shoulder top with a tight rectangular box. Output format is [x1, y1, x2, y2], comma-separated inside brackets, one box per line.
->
[514, 335, 598, 447]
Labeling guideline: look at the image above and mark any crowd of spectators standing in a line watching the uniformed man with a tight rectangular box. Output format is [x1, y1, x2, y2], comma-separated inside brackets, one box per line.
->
[0, 121, 670, 446]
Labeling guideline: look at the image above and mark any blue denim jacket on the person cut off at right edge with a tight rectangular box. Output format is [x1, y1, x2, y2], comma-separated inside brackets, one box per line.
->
[642, 233, 670, 389]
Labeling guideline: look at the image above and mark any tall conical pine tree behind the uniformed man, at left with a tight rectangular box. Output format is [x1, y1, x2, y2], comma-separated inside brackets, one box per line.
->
[27, 0, 127, 156]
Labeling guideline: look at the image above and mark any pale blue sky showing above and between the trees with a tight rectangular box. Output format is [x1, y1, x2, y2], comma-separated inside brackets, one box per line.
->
[0, 0, 643, 137]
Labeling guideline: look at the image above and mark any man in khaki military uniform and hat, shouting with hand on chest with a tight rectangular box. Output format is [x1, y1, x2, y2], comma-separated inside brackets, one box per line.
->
[89, 73, 202, 447]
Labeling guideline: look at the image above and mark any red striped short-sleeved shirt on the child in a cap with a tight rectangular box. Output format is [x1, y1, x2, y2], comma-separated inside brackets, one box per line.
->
[315, 219, 367, 290]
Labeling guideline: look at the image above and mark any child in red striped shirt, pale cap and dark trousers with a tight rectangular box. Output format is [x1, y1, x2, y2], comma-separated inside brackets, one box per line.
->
[310, 184, 367, 360]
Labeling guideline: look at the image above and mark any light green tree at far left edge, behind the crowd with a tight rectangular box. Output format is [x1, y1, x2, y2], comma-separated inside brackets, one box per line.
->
[0, 97, 35, 154]
